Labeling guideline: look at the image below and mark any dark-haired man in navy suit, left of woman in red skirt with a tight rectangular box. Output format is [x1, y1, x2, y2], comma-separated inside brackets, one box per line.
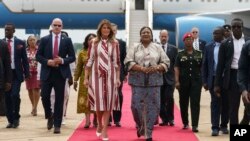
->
[4, 23, 30, 128]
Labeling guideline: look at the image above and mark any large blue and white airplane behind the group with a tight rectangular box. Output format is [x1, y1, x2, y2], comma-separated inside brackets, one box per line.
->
[0, 0, 250, 48]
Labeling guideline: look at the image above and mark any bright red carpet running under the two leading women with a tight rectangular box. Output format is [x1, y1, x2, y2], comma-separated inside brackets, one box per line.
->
[68, 84, 198, 141]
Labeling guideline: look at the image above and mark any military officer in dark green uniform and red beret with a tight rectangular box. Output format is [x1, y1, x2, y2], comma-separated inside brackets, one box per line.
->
[174, 33, 202, 132]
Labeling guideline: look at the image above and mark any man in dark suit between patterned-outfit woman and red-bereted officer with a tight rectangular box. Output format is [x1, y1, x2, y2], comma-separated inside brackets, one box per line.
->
[159, 29, 178, 126]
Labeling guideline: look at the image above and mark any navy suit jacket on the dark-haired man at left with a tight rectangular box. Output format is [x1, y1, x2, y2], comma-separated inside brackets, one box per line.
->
[4, 37, 30, 82]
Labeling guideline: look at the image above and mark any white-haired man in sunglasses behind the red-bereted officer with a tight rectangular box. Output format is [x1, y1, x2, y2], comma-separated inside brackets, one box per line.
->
[191, 27, 206, 53]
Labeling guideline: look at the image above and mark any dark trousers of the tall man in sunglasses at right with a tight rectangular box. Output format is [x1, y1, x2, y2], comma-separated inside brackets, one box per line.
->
[228, 69, 241, 124]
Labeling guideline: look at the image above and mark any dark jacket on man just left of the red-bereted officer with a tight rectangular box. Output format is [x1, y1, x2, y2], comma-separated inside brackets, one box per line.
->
[163, 43, 178, 85]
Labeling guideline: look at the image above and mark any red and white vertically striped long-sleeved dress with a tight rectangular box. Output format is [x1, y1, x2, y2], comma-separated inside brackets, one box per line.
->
[86, 40, 120, 111]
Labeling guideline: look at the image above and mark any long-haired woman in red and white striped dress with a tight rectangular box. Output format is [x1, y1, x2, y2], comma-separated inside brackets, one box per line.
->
[84, 19, 120, 140]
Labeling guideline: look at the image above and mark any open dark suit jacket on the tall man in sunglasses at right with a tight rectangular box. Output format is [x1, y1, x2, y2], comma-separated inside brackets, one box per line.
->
[214, 37, 250, 89]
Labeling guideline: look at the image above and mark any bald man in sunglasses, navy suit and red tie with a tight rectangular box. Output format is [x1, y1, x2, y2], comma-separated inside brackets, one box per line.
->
[36, 18, 76, 134]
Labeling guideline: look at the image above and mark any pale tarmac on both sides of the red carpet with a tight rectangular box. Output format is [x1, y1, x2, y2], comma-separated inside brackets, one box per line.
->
[0, 83, 243, 141]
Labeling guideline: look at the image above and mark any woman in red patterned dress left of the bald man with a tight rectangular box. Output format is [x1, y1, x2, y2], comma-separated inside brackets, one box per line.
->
[25, 35, 40, 116]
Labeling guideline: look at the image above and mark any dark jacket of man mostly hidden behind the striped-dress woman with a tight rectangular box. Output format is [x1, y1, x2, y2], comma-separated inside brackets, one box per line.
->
[117, 39, 127, 81]
